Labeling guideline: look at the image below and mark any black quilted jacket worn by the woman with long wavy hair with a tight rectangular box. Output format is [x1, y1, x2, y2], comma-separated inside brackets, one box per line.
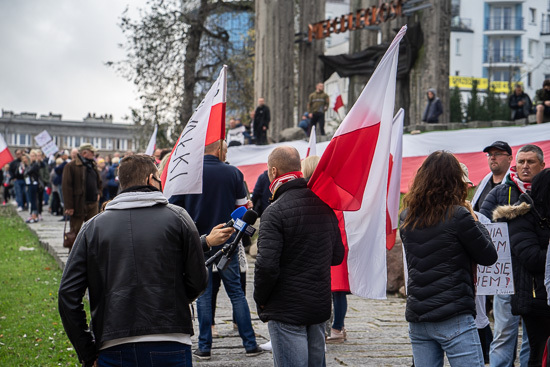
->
[401, 206, 498, 322]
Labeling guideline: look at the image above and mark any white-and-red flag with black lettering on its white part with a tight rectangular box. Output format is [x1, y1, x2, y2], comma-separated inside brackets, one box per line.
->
[161, 65, 227, 198]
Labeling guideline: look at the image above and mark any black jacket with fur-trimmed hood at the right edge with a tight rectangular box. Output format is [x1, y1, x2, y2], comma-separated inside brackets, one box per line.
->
[494, 194, 550, 317]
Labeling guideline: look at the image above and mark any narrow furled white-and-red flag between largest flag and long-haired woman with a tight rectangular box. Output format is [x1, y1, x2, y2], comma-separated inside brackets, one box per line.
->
[386, 108, 405, 250]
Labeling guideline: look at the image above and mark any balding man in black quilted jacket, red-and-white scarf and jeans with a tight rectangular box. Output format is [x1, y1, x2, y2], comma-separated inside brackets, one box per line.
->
[254, 147, 344, 366]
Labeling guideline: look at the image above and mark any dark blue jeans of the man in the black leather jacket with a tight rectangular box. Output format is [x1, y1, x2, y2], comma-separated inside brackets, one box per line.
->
[97, 342, 193, 367]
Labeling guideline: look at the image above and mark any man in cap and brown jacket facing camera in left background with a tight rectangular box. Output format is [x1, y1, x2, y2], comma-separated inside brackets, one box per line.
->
[61, 143, 101, 244]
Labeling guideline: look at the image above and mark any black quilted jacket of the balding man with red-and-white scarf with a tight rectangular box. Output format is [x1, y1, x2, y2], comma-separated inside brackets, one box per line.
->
[254, 179, 344, 325]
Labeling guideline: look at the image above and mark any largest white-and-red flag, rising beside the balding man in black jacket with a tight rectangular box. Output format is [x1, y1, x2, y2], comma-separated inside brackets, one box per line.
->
[308, 26, 407, 299]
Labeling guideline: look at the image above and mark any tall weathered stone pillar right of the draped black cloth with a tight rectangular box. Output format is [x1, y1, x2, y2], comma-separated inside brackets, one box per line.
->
[409, 0, 451, 124]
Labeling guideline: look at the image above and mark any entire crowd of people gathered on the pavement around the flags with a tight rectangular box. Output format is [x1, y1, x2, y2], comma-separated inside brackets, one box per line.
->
[2, 105, 550, 366]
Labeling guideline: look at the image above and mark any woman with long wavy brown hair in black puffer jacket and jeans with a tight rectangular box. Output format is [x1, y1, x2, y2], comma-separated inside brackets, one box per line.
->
[400, 151, 497, 367]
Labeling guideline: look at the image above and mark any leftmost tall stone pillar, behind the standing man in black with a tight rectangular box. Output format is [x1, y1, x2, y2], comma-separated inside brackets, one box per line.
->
[254, 0, 295, 141]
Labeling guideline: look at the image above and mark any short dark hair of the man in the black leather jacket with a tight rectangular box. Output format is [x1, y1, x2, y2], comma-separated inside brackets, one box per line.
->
[118, 154, 158, 190]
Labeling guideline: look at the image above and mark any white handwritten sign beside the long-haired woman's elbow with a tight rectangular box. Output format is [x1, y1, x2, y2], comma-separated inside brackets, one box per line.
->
[477, 223, 514, 296]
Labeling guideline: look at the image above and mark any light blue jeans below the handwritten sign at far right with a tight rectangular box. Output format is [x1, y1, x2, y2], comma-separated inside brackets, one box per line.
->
[489, 294, 529, 367]
